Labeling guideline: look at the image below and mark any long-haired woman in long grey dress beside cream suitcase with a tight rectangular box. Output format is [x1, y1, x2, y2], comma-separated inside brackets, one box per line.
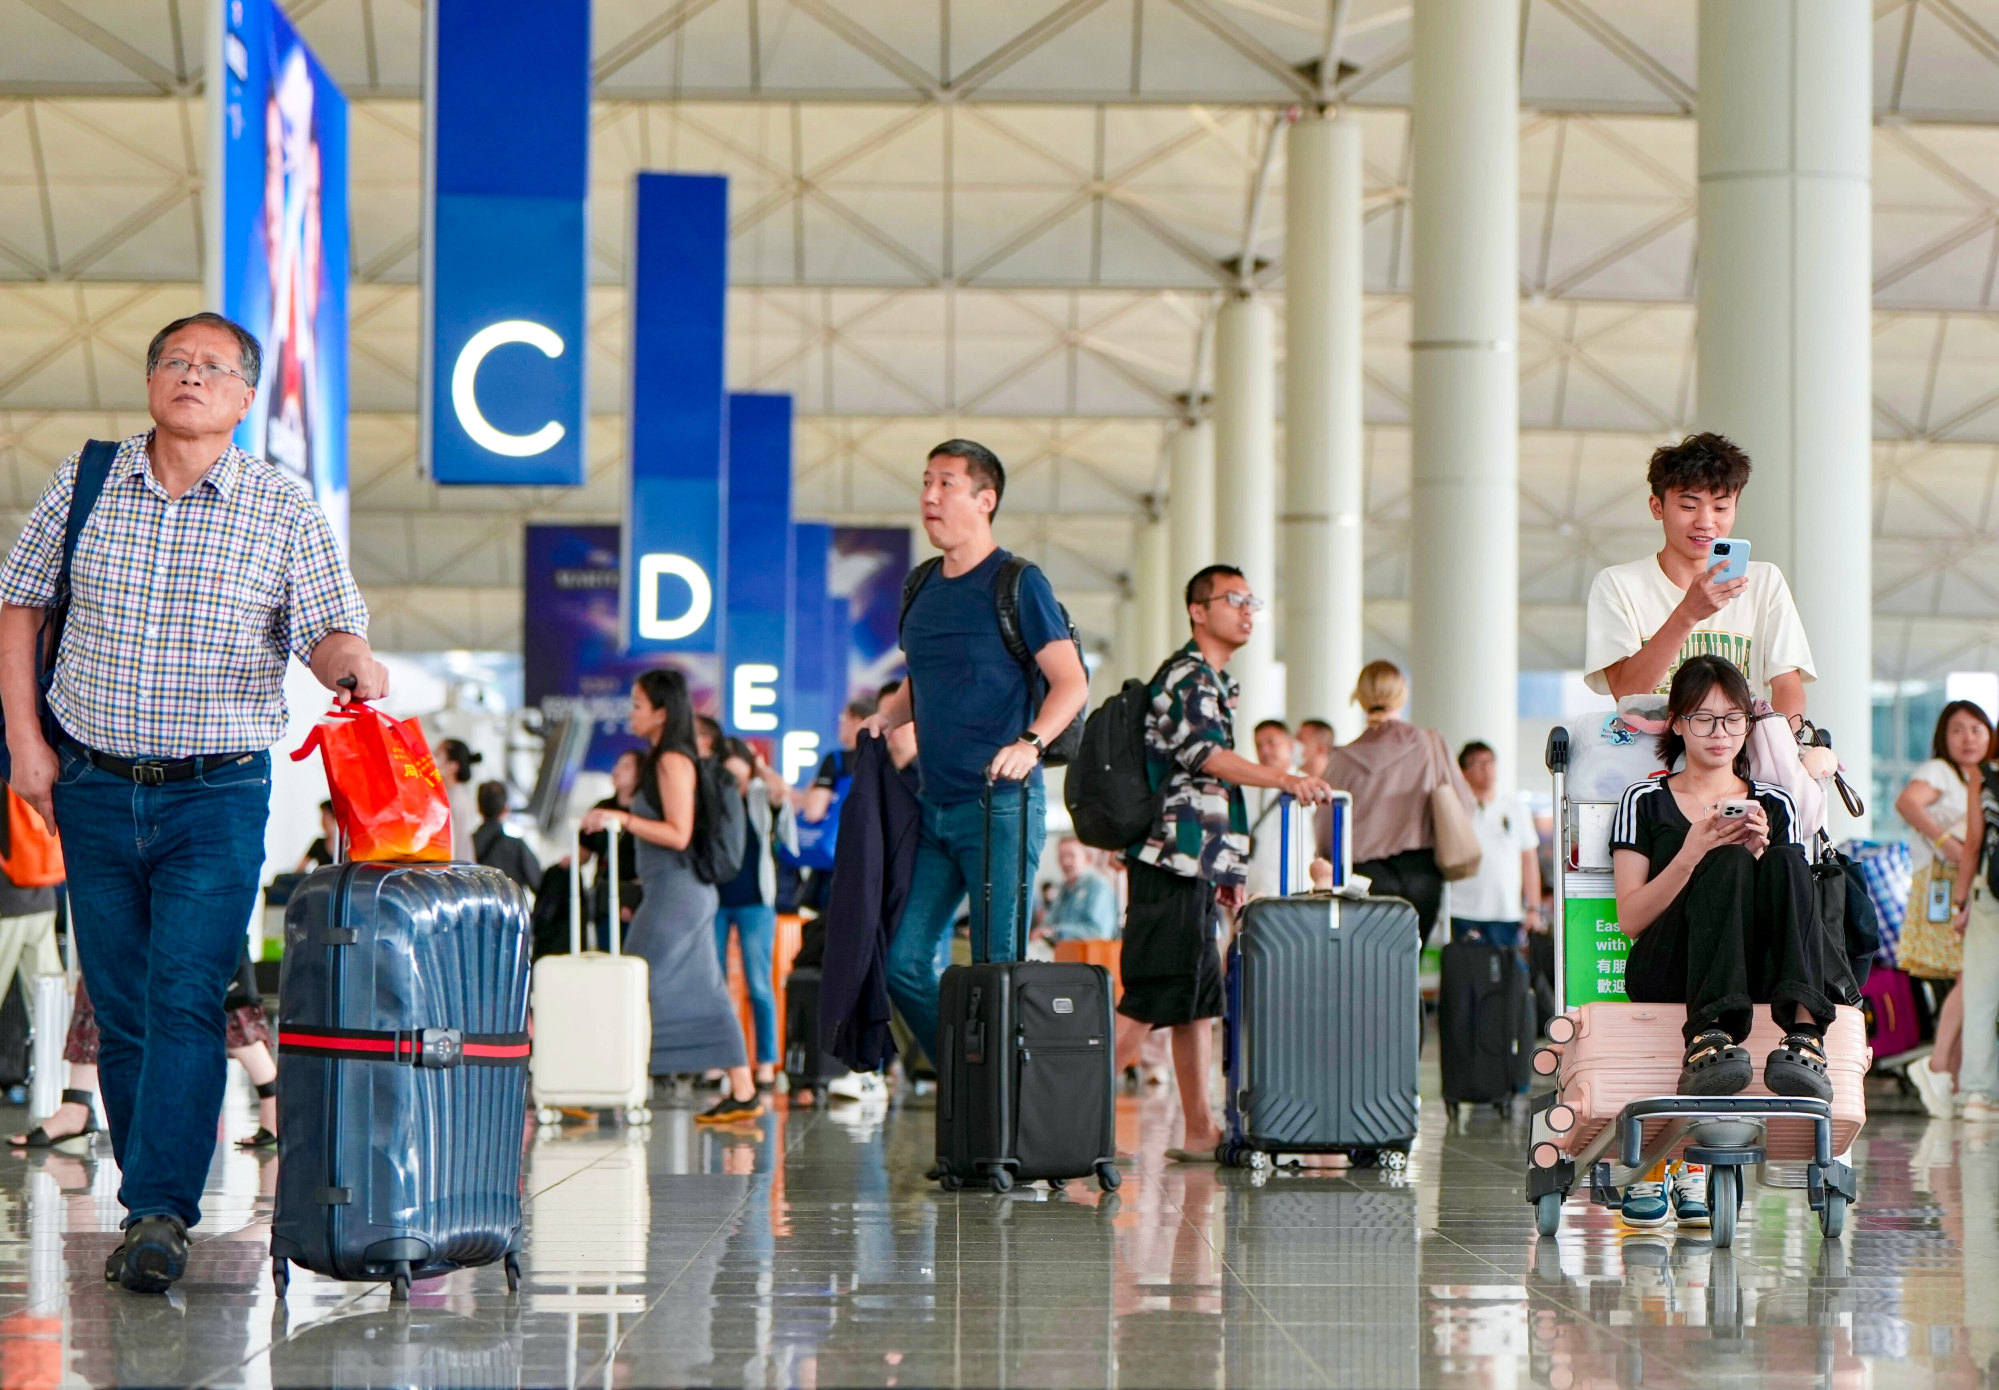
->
[584, 670, 764, 1124]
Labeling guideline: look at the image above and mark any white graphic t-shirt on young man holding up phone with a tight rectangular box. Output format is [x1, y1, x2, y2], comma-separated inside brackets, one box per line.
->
[1583, 556, 1819, 700]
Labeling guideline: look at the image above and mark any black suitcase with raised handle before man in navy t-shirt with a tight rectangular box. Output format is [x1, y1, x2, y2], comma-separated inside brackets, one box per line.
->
[934, 784, 1119, 1192]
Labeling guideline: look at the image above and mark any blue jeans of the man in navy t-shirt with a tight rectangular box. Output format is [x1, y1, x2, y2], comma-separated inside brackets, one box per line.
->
[888, 786, 1047, 1066]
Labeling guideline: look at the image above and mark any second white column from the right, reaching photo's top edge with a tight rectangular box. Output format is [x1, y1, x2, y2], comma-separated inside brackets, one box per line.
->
[1409, 0, 1519, 784]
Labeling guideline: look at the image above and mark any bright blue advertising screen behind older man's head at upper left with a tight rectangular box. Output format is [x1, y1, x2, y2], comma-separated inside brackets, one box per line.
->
[206, 0, 348, 548]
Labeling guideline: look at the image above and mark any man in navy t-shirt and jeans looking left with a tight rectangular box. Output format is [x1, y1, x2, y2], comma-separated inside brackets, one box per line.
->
[868, 440, 1089, 1058]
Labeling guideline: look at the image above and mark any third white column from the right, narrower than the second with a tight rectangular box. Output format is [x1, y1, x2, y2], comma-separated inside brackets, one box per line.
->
[1283, 116, 1363, 740]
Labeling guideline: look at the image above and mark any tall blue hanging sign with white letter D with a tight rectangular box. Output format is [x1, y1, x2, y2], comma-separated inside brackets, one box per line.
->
[624, 174, 730, 652]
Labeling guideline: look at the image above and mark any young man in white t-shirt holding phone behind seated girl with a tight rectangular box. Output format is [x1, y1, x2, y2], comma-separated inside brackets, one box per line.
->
[1583, 434, 1817, 714]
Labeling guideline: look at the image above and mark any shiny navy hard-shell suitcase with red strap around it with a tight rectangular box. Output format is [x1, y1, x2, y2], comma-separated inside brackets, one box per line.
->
[270, 864, 530, 1298]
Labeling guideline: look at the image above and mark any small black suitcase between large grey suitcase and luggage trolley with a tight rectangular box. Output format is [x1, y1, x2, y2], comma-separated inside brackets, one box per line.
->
[1437, 942, 1535, 1106]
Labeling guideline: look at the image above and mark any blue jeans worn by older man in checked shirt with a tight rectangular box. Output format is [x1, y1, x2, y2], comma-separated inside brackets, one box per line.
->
[56, 742, 270, 1226]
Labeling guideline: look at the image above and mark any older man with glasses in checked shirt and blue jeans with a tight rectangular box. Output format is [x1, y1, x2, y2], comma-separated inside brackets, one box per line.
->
[0, 314, 388, 1292]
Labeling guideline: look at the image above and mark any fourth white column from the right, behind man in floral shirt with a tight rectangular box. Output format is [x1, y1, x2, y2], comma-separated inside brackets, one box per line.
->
[1213, 296, 1283, 728]
